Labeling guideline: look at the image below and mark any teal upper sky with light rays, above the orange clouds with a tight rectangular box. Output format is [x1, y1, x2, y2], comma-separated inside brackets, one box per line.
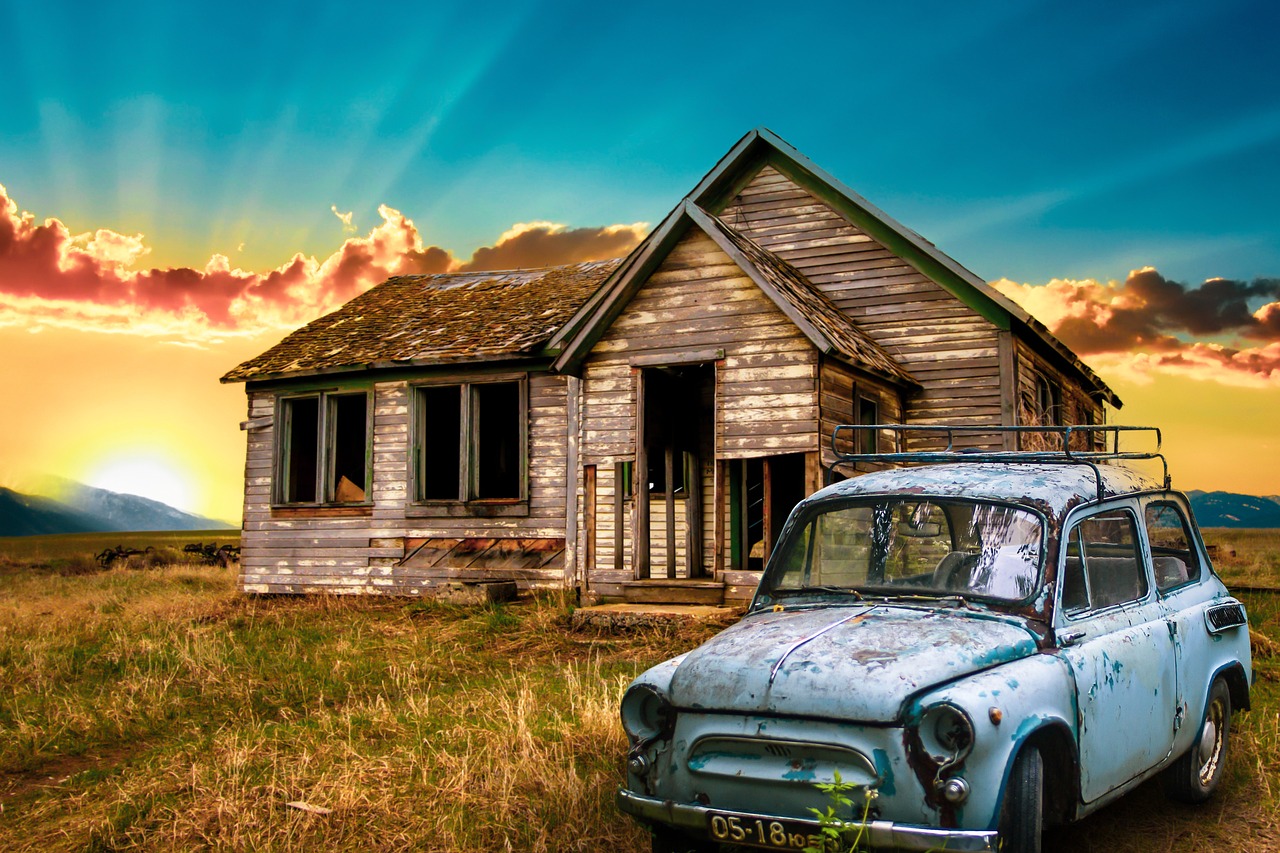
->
[0, 0, 1280, 284]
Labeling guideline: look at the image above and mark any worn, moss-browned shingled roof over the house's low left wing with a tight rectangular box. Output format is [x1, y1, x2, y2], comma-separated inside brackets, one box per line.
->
[221, 260, 621, 382]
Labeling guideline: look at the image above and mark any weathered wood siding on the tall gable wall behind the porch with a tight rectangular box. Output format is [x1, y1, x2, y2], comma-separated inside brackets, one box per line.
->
[719, 167, 1001, 450]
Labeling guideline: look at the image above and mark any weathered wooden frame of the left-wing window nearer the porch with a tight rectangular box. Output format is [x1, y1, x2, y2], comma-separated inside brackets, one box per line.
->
[406, 373, 530, 517]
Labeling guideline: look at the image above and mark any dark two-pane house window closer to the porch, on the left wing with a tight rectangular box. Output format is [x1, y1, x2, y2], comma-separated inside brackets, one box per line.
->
[416, 380, 527, 502]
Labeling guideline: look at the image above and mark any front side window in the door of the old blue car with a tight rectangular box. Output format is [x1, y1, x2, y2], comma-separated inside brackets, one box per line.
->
[1062, 510, 1147, 612]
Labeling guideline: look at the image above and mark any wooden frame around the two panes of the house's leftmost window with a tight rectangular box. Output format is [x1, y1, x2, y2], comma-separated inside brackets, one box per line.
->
[271, 388, 374, 508]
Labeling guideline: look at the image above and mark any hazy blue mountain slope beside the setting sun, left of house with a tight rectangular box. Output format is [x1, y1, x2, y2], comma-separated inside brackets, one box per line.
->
[0, 478, 233, 537]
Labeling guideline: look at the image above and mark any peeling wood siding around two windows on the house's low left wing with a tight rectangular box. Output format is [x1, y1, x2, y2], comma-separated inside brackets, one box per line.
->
[241, 374, 568, 594]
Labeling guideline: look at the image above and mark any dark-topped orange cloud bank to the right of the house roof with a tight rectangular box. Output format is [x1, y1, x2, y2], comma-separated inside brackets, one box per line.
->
[993, 266, 1280, 387]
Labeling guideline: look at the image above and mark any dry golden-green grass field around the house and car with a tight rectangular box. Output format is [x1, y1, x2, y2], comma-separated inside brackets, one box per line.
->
[0, 532, 1280, 853]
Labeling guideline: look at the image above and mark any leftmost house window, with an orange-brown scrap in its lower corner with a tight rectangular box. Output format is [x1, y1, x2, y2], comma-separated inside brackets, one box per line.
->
[275, 391, 369, 503]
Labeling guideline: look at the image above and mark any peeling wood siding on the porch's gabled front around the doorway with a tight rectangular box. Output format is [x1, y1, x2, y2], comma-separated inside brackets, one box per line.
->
[581, 232, 818, 596]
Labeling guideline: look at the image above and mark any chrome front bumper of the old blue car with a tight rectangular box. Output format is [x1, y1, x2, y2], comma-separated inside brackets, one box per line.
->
[618, 788, 998, 853]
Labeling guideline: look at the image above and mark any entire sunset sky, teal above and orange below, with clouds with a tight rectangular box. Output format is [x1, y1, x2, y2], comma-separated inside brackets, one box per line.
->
[0, 0, 1280, 521]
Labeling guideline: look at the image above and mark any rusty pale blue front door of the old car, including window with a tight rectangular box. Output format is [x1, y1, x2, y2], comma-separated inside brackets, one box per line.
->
[1057, 505, 1178, 803]
